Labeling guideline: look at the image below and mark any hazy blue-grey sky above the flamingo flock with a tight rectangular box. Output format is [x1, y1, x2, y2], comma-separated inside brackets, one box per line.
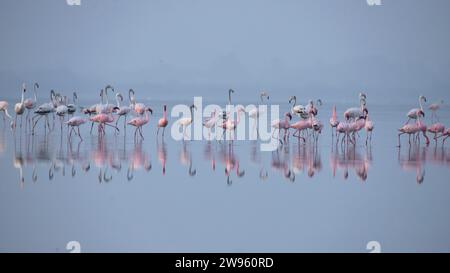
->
[0, 0, 450, 103]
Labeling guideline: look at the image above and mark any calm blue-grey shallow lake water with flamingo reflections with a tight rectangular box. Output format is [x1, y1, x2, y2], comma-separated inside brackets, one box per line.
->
[0, 101, 450, 252]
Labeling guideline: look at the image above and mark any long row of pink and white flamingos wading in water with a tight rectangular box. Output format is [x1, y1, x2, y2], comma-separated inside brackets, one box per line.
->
[0, 83, 450, 147]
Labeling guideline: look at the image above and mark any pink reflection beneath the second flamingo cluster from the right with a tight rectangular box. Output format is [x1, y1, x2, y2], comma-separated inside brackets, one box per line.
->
[330, 142, 373, 181]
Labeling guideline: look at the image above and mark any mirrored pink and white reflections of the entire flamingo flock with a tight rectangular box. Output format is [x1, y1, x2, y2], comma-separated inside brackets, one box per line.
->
[0, 124, 450, 188]
